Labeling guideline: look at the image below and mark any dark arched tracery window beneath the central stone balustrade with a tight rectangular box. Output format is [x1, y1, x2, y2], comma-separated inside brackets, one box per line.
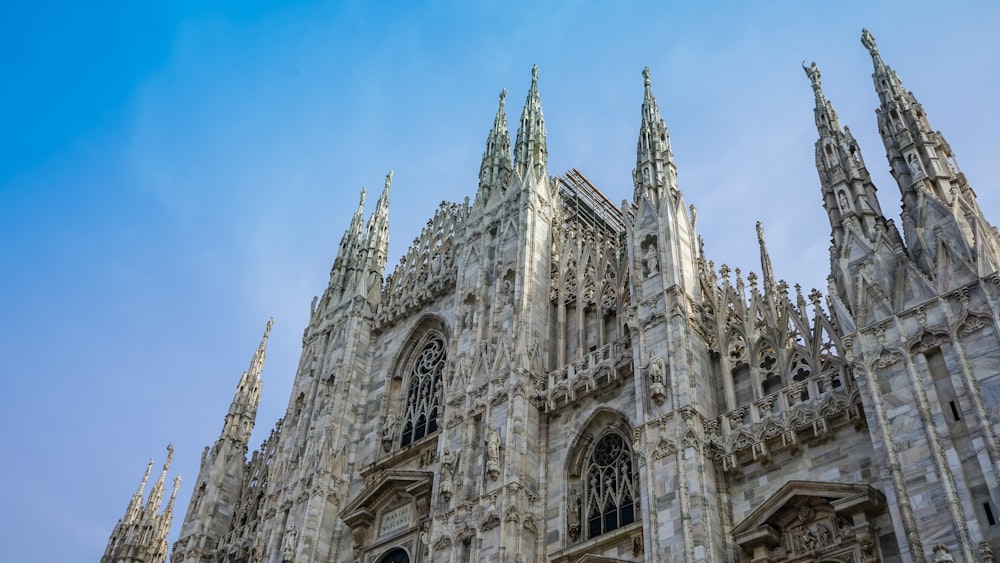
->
[583, 432, 635, 538]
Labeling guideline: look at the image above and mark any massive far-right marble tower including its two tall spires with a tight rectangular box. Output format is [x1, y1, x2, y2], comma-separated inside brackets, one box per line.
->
[806, 30, 1000, 561]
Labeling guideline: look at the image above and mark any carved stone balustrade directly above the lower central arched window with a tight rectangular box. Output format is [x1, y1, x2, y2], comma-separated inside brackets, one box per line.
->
[545, 338, 632, 411]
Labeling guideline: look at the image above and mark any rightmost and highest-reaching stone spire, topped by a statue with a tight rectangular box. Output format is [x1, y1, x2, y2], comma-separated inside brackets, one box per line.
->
[861, 29, 1000, 279]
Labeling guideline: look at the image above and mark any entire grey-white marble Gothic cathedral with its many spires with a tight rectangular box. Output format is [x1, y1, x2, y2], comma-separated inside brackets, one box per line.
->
[102, 31, 1000, 563]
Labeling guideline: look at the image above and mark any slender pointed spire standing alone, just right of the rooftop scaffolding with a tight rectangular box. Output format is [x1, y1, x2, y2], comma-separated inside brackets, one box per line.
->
[632, 67, 677, 205]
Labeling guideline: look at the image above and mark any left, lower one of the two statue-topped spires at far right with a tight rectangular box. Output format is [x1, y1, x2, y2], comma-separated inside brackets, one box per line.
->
[802, 59, 886, 248]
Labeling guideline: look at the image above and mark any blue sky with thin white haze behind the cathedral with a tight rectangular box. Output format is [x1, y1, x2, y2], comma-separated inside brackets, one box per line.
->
[0, 1, 1000, 561]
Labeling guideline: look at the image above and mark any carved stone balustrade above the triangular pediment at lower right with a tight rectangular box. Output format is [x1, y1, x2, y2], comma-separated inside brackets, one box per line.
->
[706, 366, 865, 471]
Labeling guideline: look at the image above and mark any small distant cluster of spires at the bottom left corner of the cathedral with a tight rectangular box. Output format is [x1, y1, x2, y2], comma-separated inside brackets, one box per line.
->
[101, 445, 181, 563]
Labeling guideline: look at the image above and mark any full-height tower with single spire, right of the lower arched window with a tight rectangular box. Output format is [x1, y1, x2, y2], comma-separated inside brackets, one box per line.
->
[626, 68, 723, 561]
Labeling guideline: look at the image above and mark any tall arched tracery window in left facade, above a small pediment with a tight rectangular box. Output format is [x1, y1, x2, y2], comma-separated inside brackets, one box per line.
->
[399, 333, 447, 446]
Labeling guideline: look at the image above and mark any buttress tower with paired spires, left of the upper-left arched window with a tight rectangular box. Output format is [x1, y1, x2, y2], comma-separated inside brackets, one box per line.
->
[248, 171, 392, 561]
